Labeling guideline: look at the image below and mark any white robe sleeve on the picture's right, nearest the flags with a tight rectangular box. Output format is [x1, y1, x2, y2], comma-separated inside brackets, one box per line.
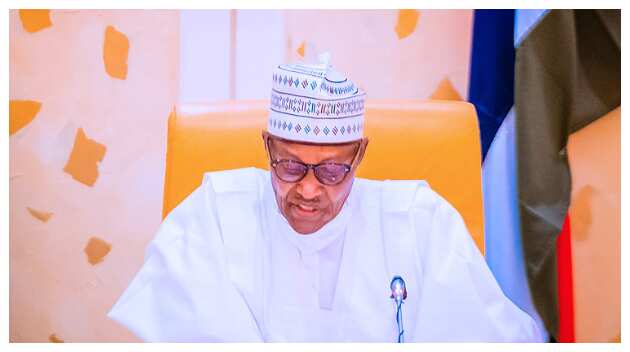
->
[412, 187, 542, 342]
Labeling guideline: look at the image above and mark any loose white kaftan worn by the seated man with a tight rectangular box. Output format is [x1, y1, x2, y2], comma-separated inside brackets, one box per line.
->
[108, 168, 541, 342]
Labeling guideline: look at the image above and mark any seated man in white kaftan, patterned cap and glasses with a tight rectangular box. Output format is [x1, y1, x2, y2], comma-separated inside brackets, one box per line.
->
[109, 64, 540, 342]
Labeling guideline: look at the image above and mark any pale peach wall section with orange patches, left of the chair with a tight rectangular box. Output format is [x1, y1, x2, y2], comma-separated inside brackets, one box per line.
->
[5, 10, 179, 342]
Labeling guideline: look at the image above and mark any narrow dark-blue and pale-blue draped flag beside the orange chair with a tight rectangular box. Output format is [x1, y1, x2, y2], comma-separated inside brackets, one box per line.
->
[469, 10, 546, 340]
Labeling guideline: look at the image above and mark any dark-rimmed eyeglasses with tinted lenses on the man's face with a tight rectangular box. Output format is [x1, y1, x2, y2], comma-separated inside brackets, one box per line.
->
[267, 140, 358, 186]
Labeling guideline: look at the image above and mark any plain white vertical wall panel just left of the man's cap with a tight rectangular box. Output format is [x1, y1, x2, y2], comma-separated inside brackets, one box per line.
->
[179, 10, 286, 103]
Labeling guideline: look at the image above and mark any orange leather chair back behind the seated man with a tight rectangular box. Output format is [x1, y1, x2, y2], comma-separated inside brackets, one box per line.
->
[162, 101, 484, 253]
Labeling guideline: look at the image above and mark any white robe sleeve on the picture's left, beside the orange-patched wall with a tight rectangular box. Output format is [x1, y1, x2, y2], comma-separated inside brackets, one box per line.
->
[108, 175, 261, 342]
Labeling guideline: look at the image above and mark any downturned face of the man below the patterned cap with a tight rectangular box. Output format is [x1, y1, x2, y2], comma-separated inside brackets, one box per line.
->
[263, 134, 367, 234]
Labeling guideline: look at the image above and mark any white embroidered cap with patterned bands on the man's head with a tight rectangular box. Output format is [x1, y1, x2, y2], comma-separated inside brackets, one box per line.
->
[267, 60, 365, 143]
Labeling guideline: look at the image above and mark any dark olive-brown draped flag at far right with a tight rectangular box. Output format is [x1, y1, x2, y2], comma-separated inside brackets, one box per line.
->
[514, 10, 621, 341]
